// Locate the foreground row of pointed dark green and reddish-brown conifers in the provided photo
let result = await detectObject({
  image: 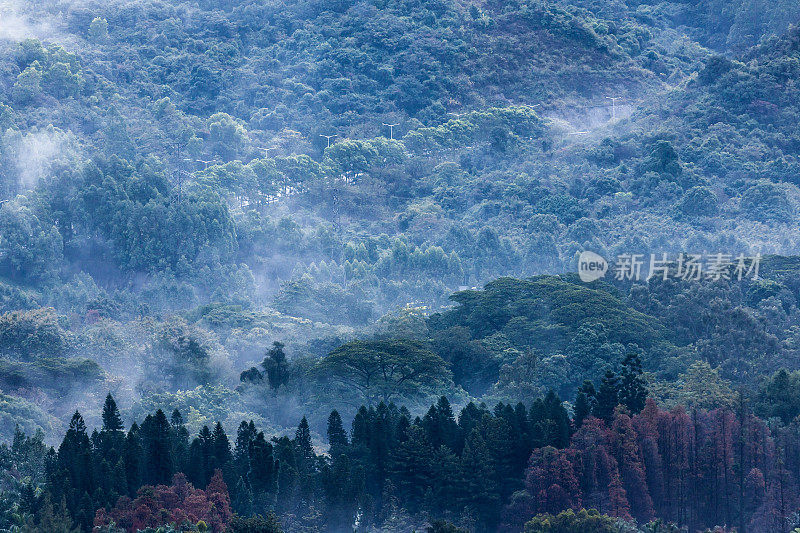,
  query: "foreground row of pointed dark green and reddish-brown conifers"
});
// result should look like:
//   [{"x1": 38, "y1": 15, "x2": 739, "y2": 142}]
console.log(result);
[{"x1": 15, "y1": 357, "x2": 800, "y2": 531}]
